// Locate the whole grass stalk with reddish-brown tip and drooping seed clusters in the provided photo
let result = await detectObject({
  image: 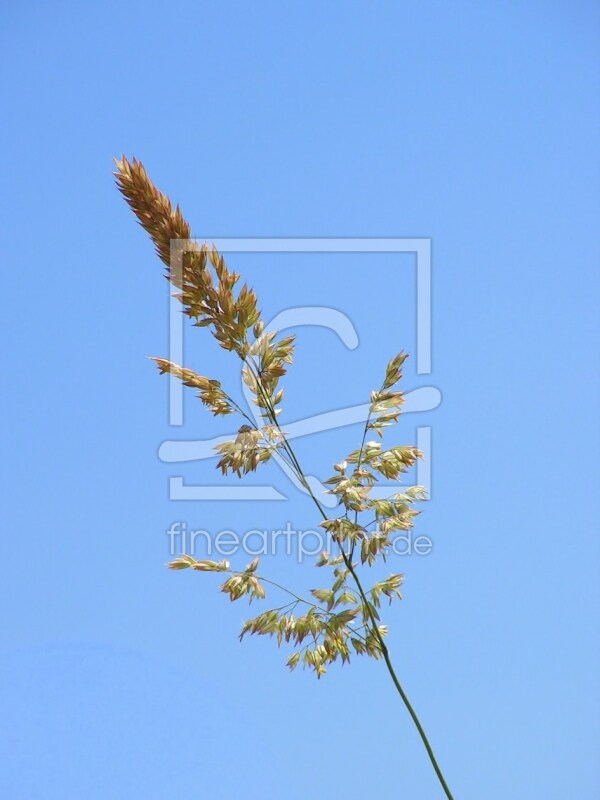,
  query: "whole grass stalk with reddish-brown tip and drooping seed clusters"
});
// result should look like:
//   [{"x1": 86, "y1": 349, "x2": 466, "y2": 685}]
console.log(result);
[{"x1": 115, "y1": 157, "x2": 452, "y2": 800}]
